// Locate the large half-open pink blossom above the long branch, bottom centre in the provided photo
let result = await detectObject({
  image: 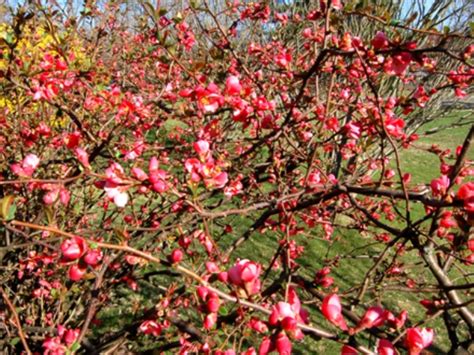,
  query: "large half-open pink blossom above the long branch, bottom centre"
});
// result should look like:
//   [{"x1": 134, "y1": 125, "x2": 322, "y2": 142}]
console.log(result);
[{"x1": 228, "y1": 259, "x2": 262, "y2": 296}]
